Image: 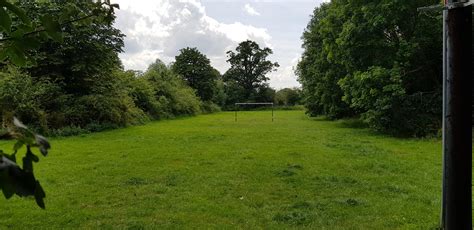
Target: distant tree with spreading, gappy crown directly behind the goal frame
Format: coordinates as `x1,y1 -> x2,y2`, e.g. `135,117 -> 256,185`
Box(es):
223,40 -> 279,101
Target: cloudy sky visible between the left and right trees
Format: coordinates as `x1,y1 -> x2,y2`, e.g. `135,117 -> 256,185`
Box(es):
111,0 -> 324,89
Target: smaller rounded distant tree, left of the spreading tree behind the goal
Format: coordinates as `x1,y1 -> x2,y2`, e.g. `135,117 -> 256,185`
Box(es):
172,47 -> 218,101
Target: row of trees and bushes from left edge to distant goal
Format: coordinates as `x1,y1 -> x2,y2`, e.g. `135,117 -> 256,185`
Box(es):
0,1 -> 299,135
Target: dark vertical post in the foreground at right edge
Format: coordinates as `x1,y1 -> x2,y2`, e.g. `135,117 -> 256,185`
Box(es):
441,0 -> 472,230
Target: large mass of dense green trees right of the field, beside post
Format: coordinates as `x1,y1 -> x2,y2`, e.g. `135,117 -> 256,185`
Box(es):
296,0 -> 442,136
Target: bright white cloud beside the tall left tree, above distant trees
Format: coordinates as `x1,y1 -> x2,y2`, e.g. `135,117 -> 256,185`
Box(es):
115,0 -> 272,73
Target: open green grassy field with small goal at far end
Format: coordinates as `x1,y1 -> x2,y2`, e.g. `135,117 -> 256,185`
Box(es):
0,111 -> 450,229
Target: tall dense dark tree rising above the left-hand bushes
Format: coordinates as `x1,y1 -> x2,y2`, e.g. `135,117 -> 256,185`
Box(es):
20,1 -> 125,97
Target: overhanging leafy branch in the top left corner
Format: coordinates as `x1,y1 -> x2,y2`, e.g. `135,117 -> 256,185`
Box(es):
0,0 -> 119,67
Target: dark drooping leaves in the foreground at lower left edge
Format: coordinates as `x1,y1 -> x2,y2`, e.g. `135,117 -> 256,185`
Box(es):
0,118 -> 51,209
